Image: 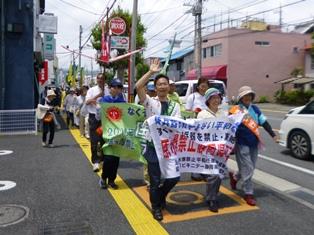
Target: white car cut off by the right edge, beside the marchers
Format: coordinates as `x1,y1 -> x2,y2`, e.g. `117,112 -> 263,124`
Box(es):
279,100 -> 314,159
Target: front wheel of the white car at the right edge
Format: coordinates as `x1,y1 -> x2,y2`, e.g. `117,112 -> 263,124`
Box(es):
288,131 -> 311,160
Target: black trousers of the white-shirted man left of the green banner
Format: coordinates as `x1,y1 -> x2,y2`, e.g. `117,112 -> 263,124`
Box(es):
88,113 -> 103,163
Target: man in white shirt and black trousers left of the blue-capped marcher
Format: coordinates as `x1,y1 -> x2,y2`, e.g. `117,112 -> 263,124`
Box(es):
85,73 -> 105,172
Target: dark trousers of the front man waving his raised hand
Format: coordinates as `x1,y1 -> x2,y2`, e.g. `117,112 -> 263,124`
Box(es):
147,162 -> 180,210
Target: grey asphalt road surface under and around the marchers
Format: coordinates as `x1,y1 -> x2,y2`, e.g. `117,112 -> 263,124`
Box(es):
0,107 -> 314,235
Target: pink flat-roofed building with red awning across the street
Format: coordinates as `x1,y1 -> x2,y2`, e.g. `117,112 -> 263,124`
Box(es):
196,28 -> 311,100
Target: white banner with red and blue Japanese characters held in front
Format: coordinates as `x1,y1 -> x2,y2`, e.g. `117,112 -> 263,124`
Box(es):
148,113 -> 243,178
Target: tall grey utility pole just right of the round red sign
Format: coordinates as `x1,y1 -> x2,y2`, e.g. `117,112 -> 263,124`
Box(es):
128,0 -> 138,102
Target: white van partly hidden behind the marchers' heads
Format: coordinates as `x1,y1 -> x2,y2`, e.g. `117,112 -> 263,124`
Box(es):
175,80 -> 228,104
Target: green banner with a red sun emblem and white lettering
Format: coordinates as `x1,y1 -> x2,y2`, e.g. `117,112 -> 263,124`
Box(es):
101,103 -> 148,163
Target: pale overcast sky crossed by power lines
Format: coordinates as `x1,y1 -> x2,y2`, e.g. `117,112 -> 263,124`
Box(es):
45,0 -> 314,69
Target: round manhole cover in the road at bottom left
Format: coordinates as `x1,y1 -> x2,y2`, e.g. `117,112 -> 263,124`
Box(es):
0,205 -> 29,227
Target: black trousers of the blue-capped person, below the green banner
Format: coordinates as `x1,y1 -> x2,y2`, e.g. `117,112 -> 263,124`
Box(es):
101,155 -> 120,182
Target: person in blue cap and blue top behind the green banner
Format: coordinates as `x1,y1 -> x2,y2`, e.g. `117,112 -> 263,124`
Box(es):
99,79 -> 125,189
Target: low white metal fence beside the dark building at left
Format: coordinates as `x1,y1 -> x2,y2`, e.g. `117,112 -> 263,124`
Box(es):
0,109 -> 37,135
